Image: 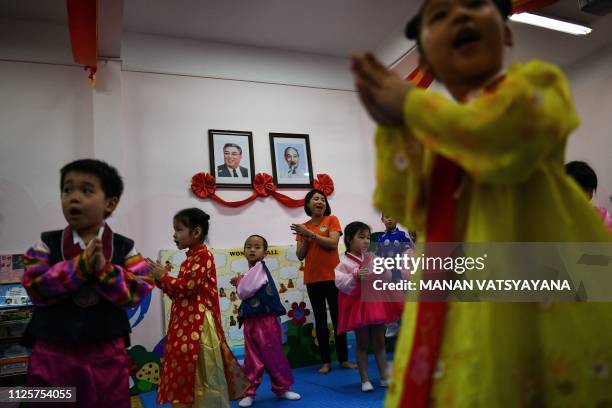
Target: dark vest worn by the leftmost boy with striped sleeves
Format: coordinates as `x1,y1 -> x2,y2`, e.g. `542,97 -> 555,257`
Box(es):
22,227 -> 134,347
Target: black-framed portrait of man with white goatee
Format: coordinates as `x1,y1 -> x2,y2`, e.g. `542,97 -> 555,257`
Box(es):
270,133 -> 313,188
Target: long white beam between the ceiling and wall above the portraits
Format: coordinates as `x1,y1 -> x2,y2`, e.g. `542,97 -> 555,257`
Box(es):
121,32 -> 353,90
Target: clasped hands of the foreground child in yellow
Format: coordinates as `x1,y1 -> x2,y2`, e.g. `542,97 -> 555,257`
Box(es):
352,52 -> 413,127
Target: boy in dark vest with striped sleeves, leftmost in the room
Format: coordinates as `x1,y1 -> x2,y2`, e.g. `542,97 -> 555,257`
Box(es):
21,159 -> 153,408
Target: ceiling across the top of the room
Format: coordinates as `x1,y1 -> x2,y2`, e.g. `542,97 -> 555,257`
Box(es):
0,0 -> 612,65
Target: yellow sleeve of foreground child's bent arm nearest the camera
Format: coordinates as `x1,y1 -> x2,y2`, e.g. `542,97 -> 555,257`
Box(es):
404,61 -> 579,184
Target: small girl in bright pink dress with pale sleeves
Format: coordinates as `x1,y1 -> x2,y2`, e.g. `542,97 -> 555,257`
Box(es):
335,221 -> 402,392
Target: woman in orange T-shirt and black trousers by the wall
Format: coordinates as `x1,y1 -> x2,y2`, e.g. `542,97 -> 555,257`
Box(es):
291,189 -> 357,374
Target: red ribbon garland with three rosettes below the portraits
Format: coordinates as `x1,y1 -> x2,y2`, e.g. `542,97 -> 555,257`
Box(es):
191,172 -> 334,208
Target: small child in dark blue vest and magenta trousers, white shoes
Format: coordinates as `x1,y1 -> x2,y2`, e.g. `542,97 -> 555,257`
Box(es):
238,235 -> 301,407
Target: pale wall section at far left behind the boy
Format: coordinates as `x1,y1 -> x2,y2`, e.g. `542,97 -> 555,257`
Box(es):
0,62 -> 93,253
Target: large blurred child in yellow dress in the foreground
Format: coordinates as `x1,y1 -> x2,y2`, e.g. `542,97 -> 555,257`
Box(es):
353,0 -> 612,408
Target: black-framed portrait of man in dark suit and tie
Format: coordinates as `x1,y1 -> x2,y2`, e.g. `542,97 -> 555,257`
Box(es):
208,129 -> 255,188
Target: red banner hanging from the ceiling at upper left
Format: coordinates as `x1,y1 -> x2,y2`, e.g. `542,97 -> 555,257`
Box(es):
66,0 -> 98,82
